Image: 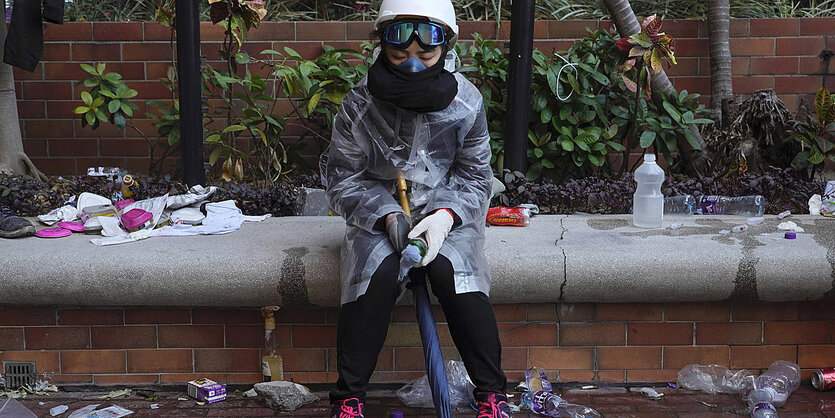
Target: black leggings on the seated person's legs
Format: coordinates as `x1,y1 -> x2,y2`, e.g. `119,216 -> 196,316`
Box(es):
330,254 -> 507,402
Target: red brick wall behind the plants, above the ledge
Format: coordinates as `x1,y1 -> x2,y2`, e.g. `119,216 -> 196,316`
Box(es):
14,18 -> 835,174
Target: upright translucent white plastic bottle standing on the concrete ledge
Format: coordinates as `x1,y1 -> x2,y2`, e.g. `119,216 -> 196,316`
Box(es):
632,154 -> 664,228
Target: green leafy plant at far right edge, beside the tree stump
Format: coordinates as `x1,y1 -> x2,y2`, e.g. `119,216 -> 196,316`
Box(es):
788,87 -> 835,172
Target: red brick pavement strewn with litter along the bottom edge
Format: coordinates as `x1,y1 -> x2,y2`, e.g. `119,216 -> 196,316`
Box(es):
9,385 -> 835,418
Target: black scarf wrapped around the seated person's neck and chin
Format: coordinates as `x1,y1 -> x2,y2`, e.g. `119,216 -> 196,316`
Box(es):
368,48 -> 458,112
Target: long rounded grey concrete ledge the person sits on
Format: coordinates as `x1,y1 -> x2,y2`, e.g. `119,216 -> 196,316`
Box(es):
0,215 -> 835,306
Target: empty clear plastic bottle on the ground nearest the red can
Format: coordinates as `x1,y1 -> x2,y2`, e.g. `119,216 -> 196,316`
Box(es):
748,360 -> 800,418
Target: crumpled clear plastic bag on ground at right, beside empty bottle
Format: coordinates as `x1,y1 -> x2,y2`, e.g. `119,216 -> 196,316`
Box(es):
676,364 -> 754,397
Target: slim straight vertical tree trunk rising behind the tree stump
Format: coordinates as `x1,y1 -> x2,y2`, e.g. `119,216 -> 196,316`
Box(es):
707,0 -> 734,125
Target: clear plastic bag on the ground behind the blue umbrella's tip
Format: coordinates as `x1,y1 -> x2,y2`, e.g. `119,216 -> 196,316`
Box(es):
397,360 -> 475,408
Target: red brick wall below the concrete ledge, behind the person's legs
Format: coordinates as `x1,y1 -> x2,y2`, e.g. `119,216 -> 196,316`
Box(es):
0,302 -> 835,385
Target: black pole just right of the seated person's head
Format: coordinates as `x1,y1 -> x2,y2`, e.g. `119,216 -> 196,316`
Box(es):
504,0 -> 534,173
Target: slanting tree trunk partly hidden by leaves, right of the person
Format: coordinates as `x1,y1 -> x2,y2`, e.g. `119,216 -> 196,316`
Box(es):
603,0 -> 707,177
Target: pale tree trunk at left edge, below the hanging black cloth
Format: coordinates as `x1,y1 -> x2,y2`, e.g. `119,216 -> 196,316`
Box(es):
0,19 -> 46,180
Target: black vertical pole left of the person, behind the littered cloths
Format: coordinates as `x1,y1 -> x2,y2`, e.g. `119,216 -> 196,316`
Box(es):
176,0 -> 206,186
